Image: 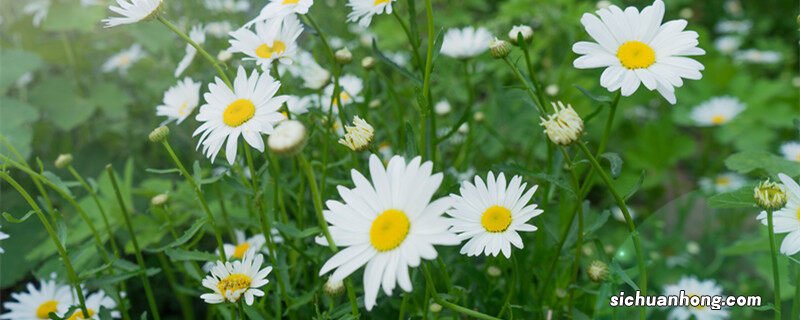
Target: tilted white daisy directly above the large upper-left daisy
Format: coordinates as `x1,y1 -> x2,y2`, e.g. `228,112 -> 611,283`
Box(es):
230,15 -> 303,70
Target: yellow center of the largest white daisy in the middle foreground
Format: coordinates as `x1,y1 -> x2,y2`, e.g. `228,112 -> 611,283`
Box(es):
369,209 -> 411,252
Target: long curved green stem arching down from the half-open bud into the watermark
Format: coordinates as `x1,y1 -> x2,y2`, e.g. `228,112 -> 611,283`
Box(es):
576,141 -> 647,319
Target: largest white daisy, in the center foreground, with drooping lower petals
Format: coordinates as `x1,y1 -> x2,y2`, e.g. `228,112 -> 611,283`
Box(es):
317,154 -> 459,310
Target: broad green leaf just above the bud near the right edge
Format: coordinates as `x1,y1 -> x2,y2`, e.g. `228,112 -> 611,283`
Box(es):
725,151 -> 800,176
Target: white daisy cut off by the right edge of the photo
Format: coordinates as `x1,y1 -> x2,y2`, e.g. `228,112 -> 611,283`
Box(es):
756,173 -> 800,256
